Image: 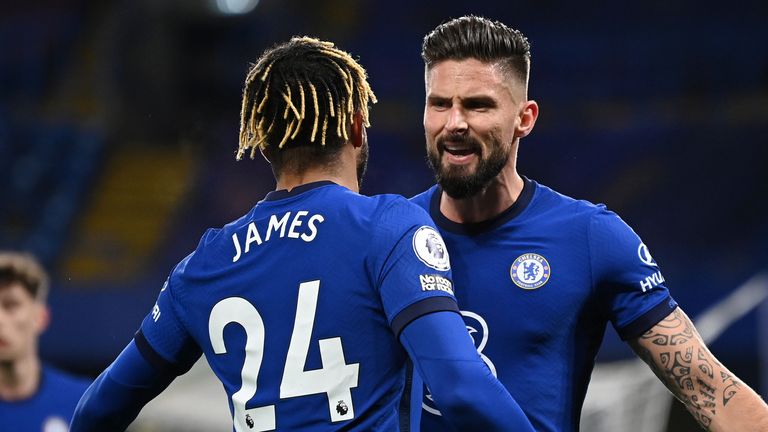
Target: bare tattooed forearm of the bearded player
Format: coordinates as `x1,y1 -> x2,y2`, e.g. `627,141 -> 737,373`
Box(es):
629,308 -> 768,431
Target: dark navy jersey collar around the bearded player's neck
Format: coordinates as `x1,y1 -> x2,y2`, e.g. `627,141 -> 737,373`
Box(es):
429,176 -> 536,235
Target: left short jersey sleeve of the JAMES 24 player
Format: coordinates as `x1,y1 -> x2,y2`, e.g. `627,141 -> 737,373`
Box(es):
134,261 -> 202,375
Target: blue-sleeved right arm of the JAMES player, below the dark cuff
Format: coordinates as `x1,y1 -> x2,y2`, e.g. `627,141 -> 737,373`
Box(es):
400,311 -> 534,432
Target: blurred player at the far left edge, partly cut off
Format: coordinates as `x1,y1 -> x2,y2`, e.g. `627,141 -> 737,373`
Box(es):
0,251 -> 90,432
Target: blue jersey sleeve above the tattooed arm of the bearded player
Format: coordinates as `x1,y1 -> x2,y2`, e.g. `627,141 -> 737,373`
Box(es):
589,207 -> 677,340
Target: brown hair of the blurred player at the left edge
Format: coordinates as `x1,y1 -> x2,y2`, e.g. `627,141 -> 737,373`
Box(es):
0,251 -> 48,303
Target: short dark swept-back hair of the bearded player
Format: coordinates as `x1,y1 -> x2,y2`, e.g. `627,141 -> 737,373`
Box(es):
421,15 -> 531,83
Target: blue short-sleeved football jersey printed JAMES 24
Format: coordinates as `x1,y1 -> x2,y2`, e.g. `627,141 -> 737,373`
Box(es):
135,182 -> 456,432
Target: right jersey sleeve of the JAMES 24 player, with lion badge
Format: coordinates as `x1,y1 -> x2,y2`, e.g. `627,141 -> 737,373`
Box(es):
372,199 -> 458,336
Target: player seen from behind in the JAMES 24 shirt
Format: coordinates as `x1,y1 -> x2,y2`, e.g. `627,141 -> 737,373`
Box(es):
72,37 -> 533,432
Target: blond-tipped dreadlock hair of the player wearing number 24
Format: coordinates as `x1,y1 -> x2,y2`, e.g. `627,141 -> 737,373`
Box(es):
237,37 -> 376,176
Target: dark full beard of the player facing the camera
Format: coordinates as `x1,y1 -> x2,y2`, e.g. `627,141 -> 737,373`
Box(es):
427,135 -> 509,199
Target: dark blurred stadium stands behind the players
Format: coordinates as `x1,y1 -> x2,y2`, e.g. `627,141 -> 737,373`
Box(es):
0,0 -> 768,431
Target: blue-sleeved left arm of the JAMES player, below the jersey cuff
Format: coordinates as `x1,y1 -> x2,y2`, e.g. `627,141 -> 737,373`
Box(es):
69,341 -> 176,432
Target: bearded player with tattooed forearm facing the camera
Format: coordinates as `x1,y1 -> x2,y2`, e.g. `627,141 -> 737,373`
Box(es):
412,16 -> 768,431
